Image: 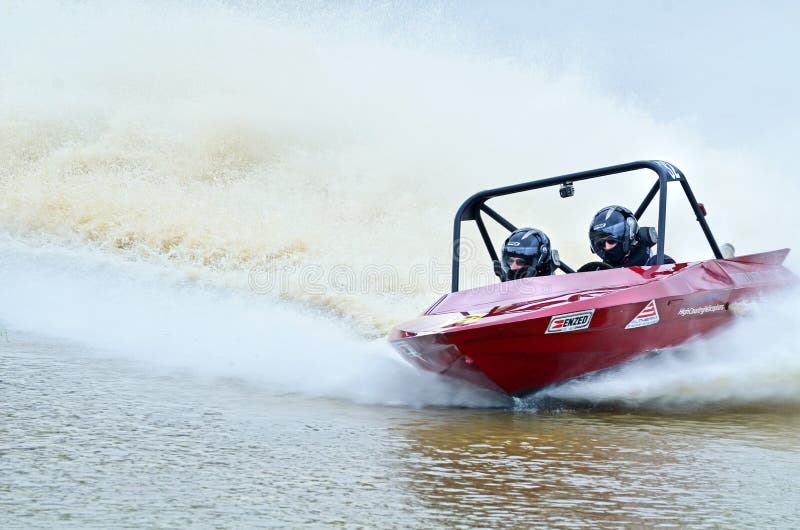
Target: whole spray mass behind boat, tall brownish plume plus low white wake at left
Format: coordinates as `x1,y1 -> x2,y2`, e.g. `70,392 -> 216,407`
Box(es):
0,2 -> 796,403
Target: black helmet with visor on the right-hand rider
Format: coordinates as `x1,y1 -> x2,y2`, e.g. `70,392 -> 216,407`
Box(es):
589,206 -> 639,266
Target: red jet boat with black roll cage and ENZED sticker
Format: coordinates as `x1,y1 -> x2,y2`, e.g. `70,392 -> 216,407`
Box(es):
389,160 -> 797,395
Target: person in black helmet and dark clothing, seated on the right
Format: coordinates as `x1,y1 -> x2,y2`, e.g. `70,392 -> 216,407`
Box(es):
589,205 -> 675,267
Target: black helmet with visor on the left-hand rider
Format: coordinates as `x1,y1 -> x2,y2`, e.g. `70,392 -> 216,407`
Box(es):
500,228 -> 556,281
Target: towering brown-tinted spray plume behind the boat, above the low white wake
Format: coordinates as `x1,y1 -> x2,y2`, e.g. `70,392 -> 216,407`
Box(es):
0,2 -> 796,337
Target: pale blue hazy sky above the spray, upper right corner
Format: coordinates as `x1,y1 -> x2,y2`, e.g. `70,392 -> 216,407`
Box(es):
461,0 -> 800,156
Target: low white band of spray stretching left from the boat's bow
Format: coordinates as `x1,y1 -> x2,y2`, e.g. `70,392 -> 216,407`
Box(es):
0,239 -> 504,406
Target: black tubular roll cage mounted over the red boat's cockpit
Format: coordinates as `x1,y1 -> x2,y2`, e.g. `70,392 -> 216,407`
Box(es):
451,160 -> 722,292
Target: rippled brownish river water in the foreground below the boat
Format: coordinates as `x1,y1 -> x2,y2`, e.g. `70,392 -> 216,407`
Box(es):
0,332 -> 800,528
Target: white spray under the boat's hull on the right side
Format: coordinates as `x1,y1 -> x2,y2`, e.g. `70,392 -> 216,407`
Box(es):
530,290 -> 800,411
